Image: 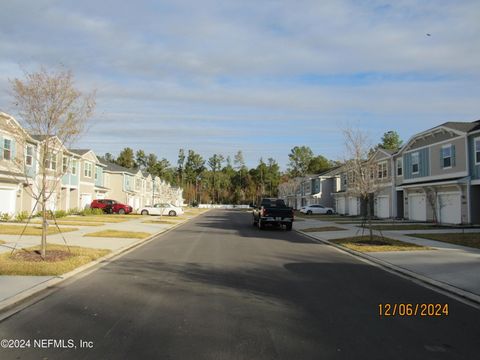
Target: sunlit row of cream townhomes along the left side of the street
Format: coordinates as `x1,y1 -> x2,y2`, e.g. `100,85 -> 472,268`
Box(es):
0,112 -> 183,214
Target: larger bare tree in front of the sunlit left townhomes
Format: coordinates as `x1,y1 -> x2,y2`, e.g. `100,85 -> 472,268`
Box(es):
11,67 -> 95,258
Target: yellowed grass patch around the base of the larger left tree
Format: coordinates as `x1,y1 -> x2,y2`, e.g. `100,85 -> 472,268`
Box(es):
0,244 -> 110,276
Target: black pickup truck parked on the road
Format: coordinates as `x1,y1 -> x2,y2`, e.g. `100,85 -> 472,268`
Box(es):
253,198 -> 294,230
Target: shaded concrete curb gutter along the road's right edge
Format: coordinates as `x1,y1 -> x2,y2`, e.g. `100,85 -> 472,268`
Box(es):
295,230 -> 480,308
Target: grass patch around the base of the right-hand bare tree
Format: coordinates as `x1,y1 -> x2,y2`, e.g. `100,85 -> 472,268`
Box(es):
329,235 -> 430,252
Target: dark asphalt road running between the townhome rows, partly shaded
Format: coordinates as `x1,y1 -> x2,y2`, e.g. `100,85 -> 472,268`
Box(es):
0,210 -> 480,360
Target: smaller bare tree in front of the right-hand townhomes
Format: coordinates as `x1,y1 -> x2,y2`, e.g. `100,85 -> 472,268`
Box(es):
343,128 -> 378,240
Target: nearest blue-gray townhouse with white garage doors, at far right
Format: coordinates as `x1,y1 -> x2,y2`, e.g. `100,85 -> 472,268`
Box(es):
394,121 -> 480,224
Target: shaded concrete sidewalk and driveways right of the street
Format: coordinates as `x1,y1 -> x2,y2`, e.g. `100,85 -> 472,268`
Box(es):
294,219 -> 480,303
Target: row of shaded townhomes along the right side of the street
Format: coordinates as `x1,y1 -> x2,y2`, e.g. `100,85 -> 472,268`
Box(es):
279,120 -> 480,224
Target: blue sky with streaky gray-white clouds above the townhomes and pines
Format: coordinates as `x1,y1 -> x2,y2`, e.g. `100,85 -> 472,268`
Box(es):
0,0 -> 480,169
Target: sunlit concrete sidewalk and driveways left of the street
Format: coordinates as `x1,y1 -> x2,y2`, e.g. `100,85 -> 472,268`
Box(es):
0,212 -> 202,311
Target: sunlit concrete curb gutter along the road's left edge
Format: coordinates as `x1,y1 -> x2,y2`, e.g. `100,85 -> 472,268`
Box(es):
0,211 -> 207,321
